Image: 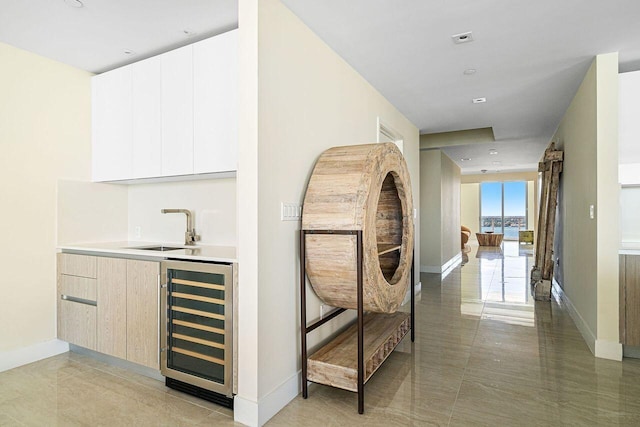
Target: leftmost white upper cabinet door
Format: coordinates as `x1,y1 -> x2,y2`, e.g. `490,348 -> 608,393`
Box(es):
91,66 -> 133,181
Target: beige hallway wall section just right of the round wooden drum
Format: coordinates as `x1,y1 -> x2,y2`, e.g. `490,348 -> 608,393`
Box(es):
420,149 -> 460,272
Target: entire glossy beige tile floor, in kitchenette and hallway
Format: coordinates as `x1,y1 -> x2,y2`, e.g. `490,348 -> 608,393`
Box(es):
0,242 -> 640,426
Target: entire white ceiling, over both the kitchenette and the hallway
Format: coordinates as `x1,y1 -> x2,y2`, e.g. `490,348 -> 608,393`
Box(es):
0,0 -> 640,173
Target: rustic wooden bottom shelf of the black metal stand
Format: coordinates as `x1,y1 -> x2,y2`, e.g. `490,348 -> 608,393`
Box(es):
307,312 -> 411,392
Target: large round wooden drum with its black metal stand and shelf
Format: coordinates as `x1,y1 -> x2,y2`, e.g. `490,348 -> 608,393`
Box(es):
300,143 -> 415,414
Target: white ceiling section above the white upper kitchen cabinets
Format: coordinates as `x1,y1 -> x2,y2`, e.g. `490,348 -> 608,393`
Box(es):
0,0 -> 238,73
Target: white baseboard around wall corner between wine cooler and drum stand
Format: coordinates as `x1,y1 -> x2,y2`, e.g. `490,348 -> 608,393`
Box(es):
233,371 -> 302,427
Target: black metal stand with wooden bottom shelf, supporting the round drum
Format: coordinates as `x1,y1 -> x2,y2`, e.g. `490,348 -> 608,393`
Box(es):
300,230 -> 415,414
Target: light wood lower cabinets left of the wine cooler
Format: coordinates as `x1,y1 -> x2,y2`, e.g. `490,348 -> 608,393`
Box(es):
58,254 -> 160,369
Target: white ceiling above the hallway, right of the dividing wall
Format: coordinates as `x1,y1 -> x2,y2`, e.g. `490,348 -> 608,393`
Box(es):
283,0 -> 640,173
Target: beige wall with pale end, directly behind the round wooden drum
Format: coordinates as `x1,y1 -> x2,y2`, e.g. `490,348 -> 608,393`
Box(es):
235,0 -> 419,422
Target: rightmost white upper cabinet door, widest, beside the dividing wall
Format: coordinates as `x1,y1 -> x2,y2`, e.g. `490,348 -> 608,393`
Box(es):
193,30 -> 238,173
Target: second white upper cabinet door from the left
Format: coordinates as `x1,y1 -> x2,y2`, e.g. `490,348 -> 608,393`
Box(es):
131,56 -> 162,178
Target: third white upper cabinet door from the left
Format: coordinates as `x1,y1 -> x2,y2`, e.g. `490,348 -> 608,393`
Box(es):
160,45 -> 193,176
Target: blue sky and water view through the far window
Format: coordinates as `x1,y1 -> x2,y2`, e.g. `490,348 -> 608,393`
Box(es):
480,181 -> 527,240
